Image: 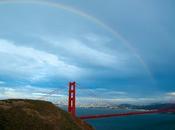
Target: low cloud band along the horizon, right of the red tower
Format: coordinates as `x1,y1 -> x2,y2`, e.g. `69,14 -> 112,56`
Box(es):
77,88 -> 175,106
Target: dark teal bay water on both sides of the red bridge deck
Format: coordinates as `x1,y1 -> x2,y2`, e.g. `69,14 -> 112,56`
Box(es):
77,108 -> 175,130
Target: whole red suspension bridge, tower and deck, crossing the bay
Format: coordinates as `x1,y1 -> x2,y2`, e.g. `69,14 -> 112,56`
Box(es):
40,82 -> 175,119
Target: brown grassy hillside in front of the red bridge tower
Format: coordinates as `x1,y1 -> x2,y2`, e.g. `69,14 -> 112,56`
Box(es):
0,99 -> 93,130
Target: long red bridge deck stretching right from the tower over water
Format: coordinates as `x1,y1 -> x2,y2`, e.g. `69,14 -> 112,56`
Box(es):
79,109 -> 175,119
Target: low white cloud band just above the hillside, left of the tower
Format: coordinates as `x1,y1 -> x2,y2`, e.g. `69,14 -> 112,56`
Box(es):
0,85 -> 67,103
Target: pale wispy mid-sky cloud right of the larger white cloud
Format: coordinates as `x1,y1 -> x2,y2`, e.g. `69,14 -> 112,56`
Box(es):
40,35 -> 127,69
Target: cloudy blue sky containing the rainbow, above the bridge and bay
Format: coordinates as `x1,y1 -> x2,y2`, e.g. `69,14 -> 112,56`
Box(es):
0,0 -> 175,104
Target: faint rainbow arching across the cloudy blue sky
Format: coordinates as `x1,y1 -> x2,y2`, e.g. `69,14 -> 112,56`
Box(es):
0,0 -> 155,84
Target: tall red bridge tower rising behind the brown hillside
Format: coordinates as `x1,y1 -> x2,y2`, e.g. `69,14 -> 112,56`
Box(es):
68,82 -> 76,116
